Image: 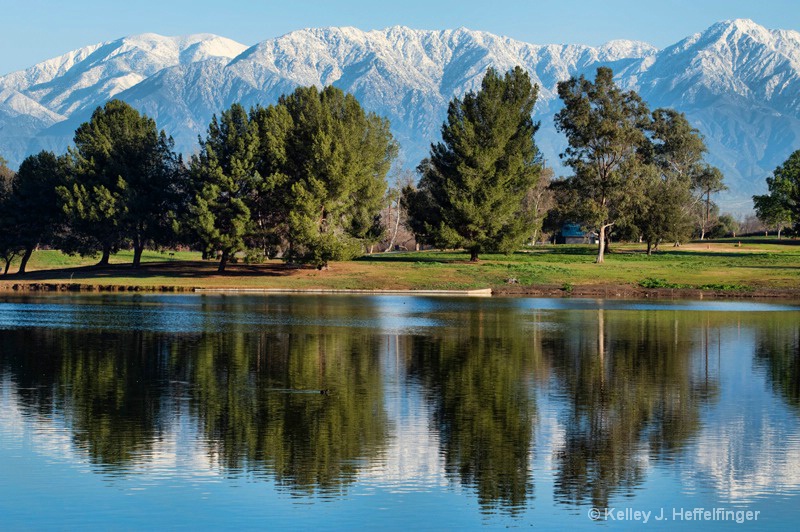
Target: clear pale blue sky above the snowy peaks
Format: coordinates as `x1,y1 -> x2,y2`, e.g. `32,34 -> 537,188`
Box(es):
0,0 -> 800,75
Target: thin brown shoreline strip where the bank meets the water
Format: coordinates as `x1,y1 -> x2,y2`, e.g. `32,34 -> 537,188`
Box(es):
0,281 -> 800,302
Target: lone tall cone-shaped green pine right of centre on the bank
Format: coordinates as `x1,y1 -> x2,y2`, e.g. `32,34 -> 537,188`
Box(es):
407,67 -> 542,261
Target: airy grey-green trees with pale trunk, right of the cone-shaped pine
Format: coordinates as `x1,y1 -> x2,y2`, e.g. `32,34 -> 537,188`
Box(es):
549,68 -> 725,262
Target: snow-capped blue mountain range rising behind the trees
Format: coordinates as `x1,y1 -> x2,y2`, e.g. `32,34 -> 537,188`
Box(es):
0,19 -> 800,212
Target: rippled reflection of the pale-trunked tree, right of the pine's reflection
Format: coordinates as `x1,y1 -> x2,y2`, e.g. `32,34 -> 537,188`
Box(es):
545,310 -> 715,508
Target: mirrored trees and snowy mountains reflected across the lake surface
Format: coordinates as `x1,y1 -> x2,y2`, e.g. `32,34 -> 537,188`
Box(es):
0,297 -> 800,516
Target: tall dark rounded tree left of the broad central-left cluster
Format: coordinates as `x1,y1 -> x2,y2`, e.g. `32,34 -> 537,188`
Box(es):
58,100 -> 183,266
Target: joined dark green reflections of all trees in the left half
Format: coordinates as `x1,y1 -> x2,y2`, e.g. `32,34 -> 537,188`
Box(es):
0,316 -> 388,494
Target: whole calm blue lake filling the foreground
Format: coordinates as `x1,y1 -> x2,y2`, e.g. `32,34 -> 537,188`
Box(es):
0,295 -> 800,530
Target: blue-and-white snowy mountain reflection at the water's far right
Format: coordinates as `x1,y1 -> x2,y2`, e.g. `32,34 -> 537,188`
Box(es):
682,327 -> 800,503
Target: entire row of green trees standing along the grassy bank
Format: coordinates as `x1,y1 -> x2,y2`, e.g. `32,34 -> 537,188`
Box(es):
0,67 -> 800,273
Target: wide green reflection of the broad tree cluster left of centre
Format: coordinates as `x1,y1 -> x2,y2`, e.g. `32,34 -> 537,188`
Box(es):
184,329 -> 388,494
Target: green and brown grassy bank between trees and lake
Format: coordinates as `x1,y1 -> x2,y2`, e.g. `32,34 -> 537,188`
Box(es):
0,239 -> 800,296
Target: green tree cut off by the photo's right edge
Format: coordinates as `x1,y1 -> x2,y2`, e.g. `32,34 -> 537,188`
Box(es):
753,150 -> 800,234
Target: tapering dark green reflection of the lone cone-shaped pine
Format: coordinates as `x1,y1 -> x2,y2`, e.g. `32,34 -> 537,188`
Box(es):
409,307 -> 540,513
